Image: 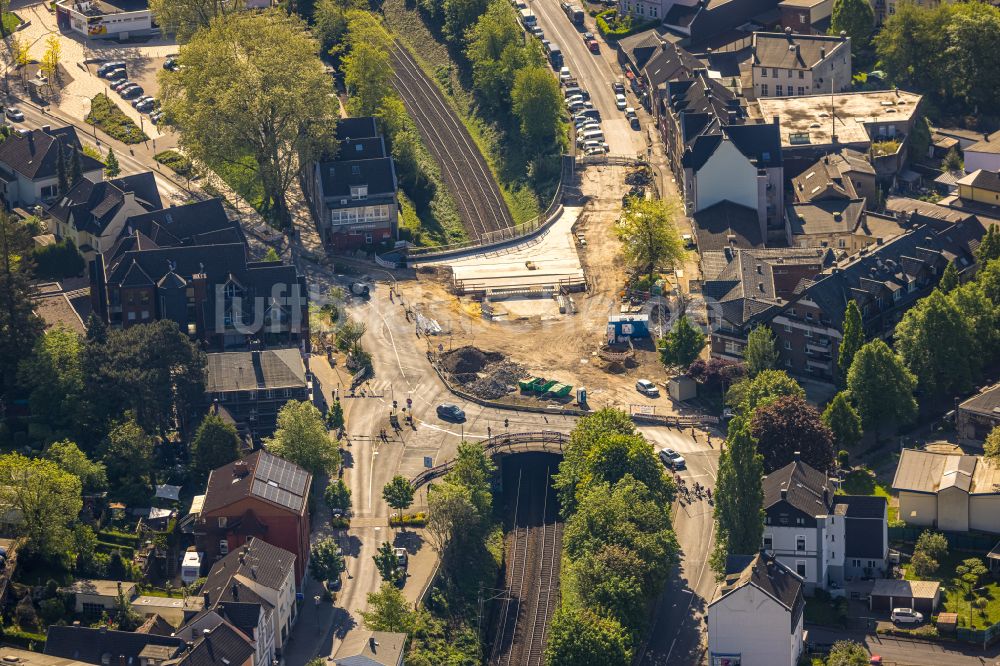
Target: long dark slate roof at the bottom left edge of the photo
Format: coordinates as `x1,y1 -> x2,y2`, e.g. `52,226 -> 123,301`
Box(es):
45,625 -> 185,665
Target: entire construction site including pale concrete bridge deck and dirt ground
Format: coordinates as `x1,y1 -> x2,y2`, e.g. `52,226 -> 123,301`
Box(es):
400,165 -> 703,407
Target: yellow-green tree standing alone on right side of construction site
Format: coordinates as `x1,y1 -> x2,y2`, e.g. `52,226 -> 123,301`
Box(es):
616,197 -> 687,282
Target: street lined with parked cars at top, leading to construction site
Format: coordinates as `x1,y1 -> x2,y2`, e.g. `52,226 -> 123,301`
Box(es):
528,0 -> 646,155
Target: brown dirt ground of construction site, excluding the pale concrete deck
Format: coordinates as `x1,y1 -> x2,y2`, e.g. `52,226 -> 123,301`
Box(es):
399,166 -> 688,413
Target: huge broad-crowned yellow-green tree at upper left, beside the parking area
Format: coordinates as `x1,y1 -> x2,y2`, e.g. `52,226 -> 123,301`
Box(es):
160,9 -> 338,228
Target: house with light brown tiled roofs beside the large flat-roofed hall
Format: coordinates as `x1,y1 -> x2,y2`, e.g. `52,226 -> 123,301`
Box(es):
792,148 -> 879,210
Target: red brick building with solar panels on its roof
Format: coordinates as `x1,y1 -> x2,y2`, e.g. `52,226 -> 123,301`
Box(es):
194,450 -> 312,584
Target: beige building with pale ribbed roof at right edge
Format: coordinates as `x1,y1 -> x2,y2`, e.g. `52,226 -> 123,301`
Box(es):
892,449 -> 1000,534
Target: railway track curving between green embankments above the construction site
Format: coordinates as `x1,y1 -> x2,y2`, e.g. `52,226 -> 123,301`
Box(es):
392,42 -> 514,239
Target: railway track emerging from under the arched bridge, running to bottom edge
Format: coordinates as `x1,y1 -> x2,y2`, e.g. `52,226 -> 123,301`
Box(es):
489,467 -> 562,666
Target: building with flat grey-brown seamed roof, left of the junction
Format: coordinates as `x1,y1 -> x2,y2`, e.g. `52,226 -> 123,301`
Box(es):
205,347 -> 310,439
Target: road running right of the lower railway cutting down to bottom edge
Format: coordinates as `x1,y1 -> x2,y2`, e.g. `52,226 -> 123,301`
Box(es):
636,428 -> 722,666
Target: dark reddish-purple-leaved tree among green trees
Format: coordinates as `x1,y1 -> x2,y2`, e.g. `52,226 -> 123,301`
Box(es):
744,396 -> 834,472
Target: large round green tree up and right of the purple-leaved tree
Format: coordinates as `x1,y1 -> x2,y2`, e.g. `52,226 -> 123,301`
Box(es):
847,339 -> 917,428
